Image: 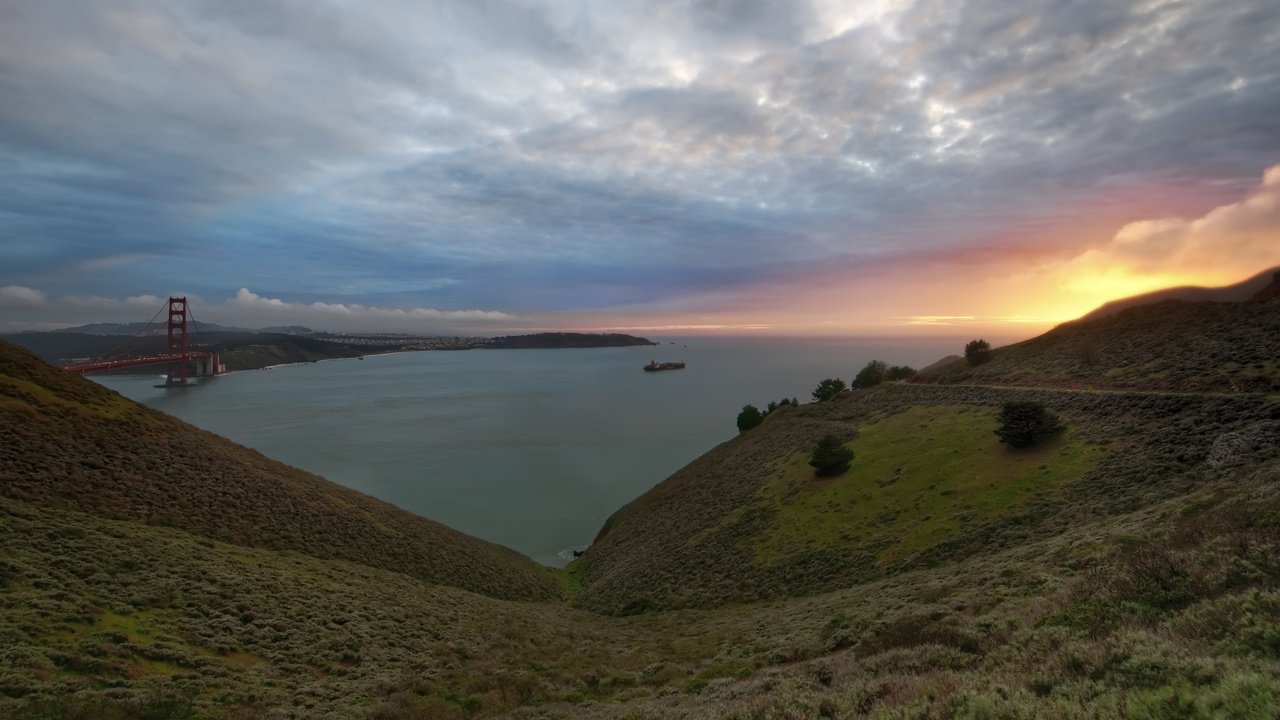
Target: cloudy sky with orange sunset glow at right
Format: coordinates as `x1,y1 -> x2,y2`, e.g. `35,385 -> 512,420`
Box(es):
0,0 -> 1280,337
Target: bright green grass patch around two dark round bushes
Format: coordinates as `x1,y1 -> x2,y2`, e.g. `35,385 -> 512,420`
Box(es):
755,406 -> 1102,564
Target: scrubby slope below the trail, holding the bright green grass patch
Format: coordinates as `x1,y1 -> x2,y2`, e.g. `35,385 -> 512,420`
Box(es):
576,384 -> 1276,614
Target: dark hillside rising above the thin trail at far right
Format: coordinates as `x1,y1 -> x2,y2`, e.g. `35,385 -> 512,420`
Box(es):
922,300 -> 1280,392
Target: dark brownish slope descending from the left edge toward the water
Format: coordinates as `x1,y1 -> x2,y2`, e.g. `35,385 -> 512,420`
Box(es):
0,345 -> 558,598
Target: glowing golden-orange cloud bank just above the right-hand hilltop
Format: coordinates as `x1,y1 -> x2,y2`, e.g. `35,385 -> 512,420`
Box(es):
1060,165 -> 1280,290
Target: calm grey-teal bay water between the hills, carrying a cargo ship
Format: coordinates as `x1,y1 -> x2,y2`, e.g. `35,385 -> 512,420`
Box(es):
95,338 -> 966,566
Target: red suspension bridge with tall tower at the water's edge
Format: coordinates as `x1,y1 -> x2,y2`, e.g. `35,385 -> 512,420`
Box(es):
64,297 -> 227,387
